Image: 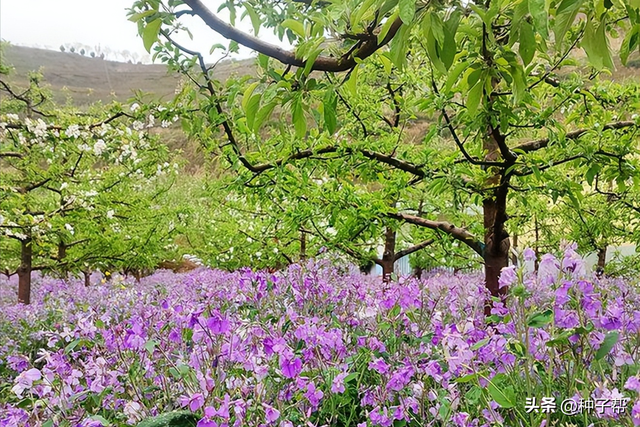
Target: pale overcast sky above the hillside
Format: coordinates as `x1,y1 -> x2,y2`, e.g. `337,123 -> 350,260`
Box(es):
0,0 -> 279,63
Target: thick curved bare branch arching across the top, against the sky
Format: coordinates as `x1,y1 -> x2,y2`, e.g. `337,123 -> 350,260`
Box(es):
181,0 -> 402,72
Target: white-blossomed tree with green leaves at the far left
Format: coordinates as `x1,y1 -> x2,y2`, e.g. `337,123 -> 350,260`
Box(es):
0,74 -> 173,304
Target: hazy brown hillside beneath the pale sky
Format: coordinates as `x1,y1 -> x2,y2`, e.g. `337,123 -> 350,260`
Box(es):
2,46 -> 253,106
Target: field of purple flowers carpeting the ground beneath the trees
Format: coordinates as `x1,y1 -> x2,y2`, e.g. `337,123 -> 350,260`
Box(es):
0,246 -> 640,427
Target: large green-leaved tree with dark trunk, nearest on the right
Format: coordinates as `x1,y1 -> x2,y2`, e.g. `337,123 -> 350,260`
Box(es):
130,0 -> 640,311
